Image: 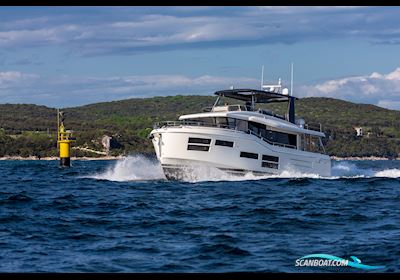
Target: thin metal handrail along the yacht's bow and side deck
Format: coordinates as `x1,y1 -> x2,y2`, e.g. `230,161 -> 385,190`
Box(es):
153,120 -> 297,149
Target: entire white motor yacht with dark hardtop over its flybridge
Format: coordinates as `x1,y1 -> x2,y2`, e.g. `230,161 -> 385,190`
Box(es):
150,79 -> 331,179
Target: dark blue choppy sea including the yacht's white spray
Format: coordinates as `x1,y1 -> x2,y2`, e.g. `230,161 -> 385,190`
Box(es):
0,159 -> 400,272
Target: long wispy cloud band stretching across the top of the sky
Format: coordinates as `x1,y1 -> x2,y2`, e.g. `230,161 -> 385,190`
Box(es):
0,7 -> 400,55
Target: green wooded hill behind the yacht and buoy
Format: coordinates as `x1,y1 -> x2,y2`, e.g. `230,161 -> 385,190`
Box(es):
0,95 -> 400,157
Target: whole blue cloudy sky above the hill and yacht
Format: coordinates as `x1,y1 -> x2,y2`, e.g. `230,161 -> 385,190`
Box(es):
0,6 -> 400,110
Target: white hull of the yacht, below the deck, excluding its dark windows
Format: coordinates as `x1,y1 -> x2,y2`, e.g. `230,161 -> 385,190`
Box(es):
150,126 -> 331,179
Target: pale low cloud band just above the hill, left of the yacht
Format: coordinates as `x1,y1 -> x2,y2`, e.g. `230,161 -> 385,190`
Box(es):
0,71 -> 258,107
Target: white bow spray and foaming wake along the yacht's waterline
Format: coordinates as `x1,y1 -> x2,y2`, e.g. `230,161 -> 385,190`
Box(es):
89,155 -> 400,182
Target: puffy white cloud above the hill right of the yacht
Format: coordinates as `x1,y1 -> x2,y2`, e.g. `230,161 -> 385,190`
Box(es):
297,67 -> 400,110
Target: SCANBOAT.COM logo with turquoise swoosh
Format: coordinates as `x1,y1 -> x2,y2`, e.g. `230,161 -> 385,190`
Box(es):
295,254 -> 385,270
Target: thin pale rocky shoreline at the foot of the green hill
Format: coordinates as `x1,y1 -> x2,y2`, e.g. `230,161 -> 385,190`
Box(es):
0,156 -> 400,160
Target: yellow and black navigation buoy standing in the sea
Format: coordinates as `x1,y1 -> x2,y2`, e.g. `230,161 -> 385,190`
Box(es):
57,110 -> 75,167
